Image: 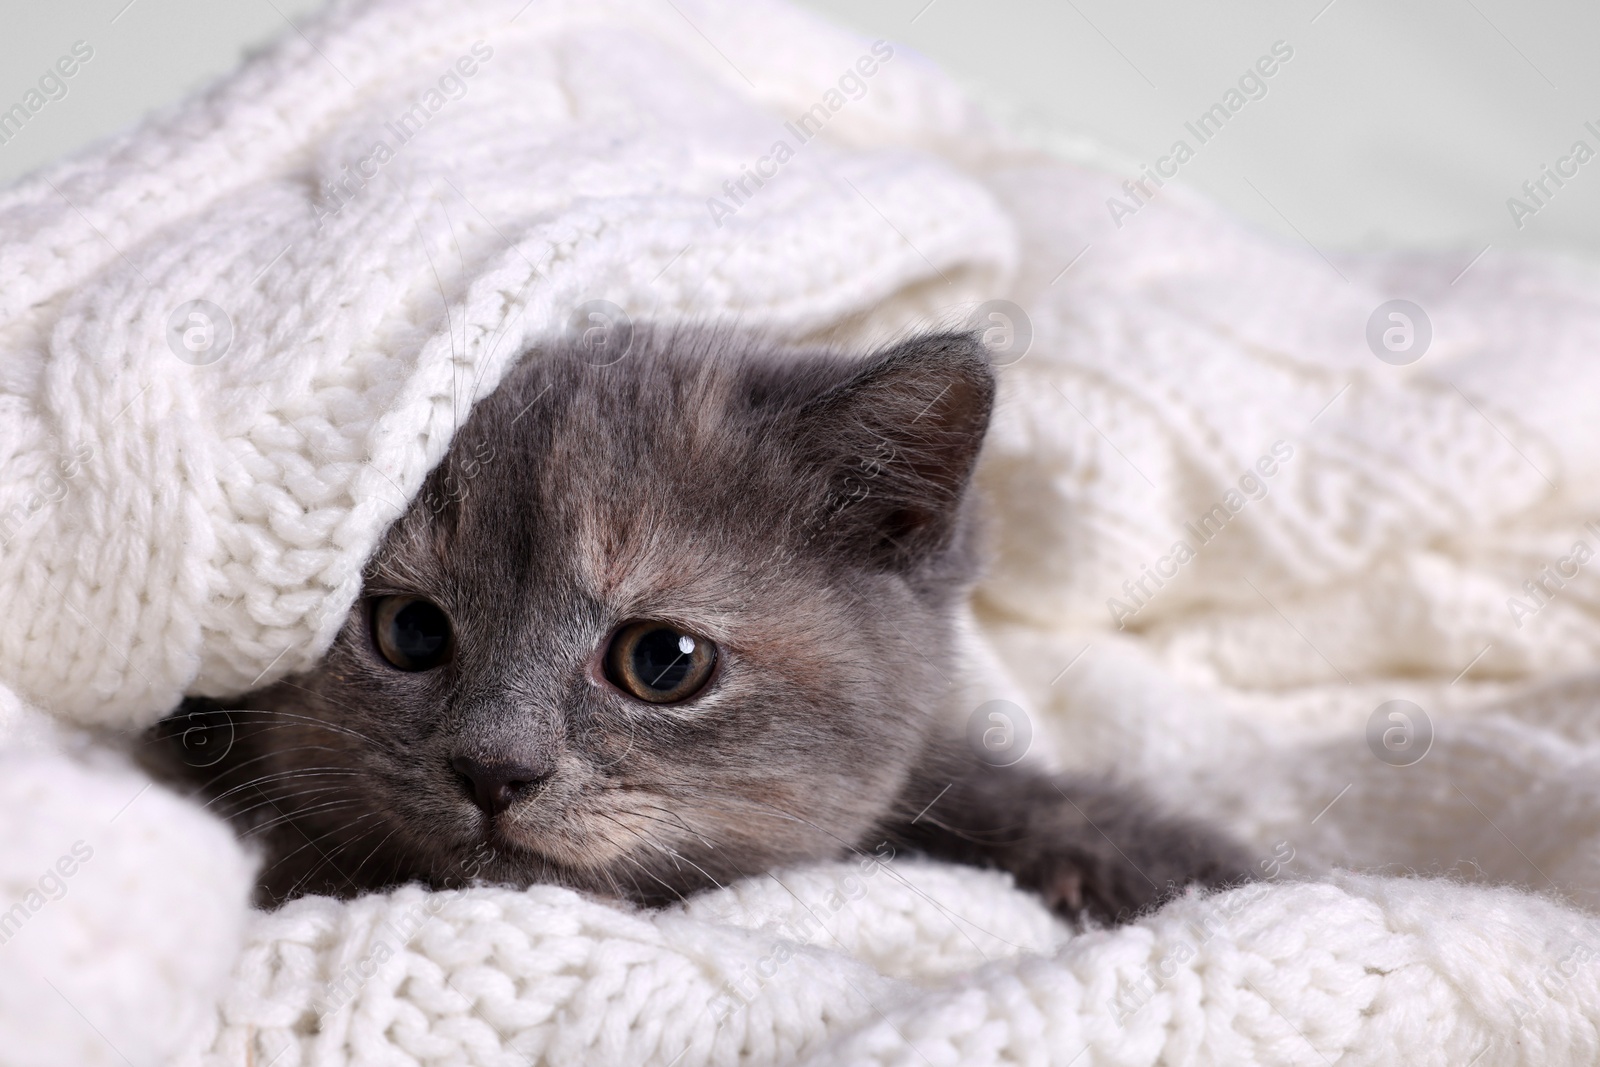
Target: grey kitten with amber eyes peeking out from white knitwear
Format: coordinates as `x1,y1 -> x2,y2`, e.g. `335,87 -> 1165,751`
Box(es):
144,331 -> 1248,921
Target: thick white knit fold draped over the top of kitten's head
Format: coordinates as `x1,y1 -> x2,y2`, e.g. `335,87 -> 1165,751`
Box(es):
0,0 -> 1014,723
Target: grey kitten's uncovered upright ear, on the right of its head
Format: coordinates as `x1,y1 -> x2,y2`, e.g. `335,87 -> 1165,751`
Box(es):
800,333 -> 995,563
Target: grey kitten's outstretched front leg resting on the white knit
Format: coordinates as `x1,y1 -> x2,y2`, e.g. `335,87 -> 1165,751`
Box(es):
883,744 -> 1251,923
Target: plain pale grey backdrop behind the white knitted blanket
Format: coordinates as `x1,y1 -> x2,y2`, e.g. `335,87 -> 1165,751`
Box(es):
0,0 -> 1600,262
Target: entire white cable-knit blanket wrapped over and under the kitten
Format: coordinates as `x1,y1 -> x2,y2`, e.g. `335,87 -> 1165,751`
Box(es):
9,0 -> 1600,1067
